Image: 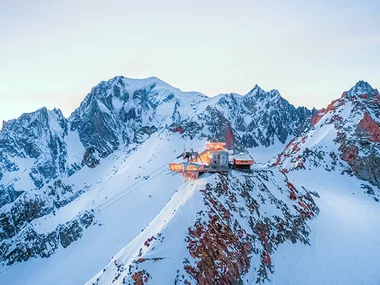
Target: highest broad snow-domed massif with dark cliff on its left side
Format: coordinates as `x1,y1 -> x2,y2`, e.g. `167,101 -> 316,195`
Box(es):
69,77 -> 206,157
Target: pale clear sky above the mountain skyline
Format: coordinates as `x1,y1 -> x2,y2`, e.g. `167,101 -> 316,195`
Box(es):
0,0 -> 380,120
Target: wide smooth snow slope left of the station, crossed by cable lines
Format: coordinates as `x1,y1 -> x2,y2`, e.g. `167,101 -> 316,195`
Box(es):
0,134 -> 196,285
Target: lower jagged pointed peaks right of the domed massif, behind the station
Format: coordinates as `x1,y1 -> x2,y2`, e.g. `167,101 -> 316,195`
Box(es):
183,85 -> 316,149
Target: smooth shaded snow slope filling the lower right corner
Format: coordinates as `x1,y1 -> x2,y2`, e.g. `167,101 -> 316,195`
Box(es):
272,169 -> 380,285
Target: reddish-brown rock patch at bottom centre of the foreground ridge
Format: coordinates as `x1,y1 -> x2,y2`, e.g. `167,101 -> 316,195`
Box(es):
184,185 -> 254,284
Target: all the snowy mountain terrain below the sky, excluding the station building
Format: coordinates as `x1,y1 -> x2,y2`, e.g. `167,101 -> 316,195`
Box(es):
0,76 -> 380,285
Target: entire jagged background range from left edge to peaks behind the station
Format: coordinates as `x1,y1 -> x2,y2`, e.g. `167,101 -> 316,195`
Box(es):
0,77 -> 311,262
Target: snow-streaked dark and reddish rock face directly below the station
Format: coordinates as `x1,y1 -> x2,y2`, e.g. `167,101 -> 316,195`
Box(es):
184,172 -> 319,284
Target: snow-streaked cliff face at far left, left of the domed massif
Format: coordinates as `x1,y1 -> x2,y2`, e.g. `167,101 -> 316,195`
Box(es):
0,108 -> 70,197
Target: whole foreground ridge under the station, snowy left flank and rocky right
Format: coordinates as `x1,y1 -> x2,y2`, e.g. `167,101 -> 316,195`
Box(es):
87,170 -> 319,285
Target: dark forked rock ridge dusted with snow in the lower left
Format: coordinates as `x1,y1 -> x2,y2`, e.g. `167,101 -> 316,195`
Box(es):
0,180 -> 95,265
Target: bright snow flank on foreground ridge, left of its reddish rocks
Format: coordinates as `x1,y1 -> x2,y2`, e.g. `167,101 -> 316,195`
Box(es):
86,178 -> 207,284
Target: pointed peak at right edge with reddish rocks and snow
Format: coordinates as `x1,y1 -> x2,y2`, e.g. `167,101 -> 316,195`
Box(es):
275,81 -> 380,191
